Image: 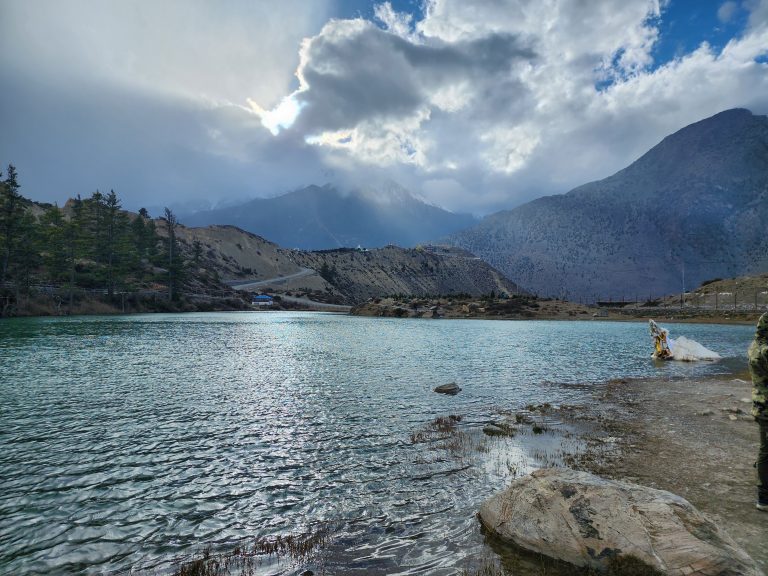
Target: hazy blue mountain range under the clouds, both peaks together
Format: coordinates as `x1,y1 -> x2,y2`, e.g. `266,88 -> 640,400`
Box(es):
184,109 -> 768,301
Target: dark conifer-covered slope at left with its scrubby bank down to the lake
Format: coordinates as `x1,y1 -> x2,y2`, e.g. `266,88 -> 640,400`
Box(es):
0,165 -> 244,315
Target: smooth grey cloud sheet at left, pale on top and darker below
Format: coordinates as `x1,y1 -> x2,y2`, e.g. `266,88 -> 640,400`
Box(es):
0,0 -> 329,208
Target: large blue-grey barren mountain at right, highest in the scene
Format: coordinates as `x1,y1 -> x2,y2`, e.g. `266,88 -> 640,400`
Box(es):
451,109 -> 768,299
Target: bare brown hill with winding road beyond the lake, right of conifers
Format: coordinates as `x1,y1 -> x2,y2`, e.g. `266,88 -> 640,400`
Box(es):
173,226 -> 520,304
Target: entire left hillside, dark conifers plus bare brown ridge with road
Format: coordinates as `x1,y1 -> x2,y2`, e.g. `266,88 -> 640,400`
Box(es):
0,166 -> 519,316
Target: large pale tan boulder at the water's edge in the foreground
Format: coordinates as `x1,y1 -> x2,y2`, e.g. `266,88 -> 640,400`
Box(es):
480,468 -> 762,576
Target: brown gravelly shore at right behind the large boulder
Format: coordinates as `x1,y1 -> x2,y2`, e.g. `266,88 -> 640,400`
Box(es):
561,374 -> 768,572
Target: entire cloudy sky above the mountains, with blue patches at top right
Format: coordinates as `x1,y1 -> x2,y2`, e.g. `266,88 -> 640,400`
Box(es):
0,0 -> 768,215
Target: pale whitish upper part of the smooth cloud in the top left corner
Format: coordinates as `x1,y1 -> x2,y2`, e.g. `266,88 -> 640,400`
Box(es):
0,0 -> 329,106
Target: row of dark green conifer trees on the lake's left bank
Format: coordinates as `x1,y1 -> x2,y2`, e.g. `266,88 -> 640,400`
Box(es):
0,164 -> 184,298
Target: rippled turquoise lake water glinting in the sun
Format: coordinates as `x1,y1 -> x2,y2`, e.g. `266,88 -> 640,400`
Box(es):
0,313 -> 754,574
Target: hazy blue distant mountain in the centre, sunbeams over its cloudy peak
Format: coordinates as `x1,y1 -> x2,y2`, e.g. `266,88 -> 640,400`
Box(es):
183,183 -> 477,250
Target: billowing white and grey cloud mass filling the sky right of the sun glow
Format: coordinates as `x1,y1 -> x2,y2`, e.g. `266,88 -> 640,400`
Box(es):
256,0 -> 768,212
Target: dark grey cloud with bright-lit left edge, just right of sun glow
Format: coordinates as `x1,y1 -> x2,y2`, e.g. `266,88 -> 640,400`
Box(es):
296,21 -> 534,133
